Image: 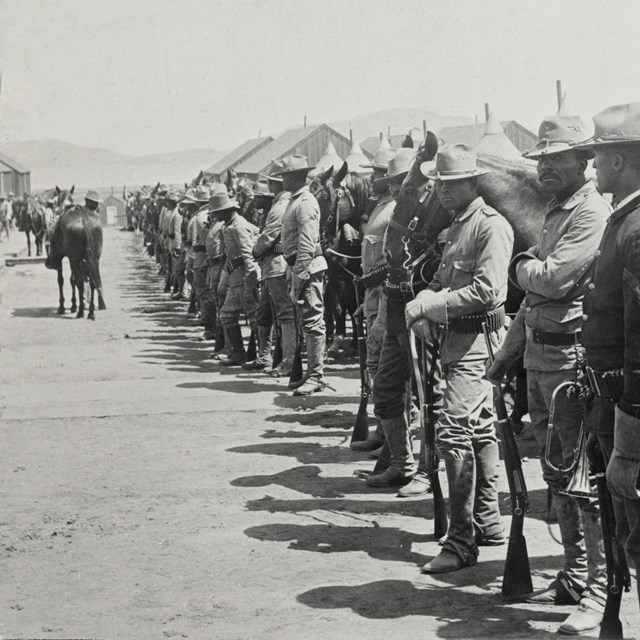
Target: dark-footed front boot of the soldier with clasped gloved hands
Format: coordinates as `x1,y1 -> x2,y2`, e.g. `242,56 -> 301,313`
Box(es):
422,452 -> 478,573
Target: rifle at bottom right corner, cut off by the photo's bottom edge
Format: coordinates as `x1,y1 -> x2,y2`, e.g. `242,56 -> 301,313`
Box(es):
590,441 -> 631,640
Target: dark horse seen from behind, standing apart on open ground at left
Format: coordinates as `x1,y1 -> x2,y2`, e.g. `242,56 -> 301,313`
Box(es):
45,187 -> 107,320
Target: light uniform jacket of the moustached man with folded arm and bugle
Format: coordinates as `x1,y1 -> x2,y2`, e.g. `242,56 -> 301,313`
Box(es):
502,182 -> 611,371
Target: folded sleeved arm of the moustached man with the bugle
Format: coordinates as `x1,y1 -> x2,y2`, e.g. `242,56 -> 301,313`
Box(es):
512,202 -> 610,300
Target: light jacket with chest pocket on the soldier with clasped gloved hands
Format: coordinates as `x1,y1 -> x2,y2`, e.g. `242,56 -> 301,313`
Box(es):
428,197 -> 513,364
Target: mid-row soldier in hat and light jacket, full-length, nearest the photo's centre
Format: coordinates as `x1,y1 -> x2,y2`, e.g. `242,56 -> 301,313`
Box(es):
278,155 -> 327,396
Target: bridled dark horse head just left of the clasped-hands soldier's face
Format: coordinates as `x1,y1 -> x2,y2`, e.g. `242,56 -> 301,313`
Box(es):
384,131 -> 449,286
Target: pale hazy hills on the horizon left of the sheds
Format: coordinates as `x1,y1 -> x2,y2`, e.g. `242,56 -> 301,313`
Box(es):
0,139 -> 226,191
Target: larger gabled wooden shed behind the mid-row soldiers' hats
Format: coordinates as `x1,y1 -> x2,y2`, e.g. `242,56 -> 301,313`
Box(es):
235,124 -> 360,180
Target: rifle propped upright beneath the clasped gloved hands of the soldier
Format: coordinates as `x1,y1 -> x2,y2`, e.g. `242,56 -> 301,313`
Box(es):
409,331 -> 448,538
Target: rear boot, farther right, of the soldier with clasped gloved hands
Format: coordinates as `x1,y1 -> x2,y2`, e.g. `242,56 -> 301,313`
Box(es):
473,438 -> 507,547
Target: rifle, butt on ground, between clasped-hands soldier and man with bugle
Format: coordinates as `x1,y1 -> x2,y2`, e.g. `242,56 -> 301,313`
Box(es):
482,322 -> 533,600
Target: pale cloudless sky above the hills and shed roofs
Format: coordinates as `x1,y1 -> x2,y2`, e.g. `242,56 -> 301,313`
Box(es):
0,0 -> 640,155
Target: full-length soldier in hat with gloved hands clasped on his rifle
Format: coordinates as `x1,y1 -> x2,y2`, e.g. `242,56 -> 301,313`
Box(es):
405,144 -> 513,573
